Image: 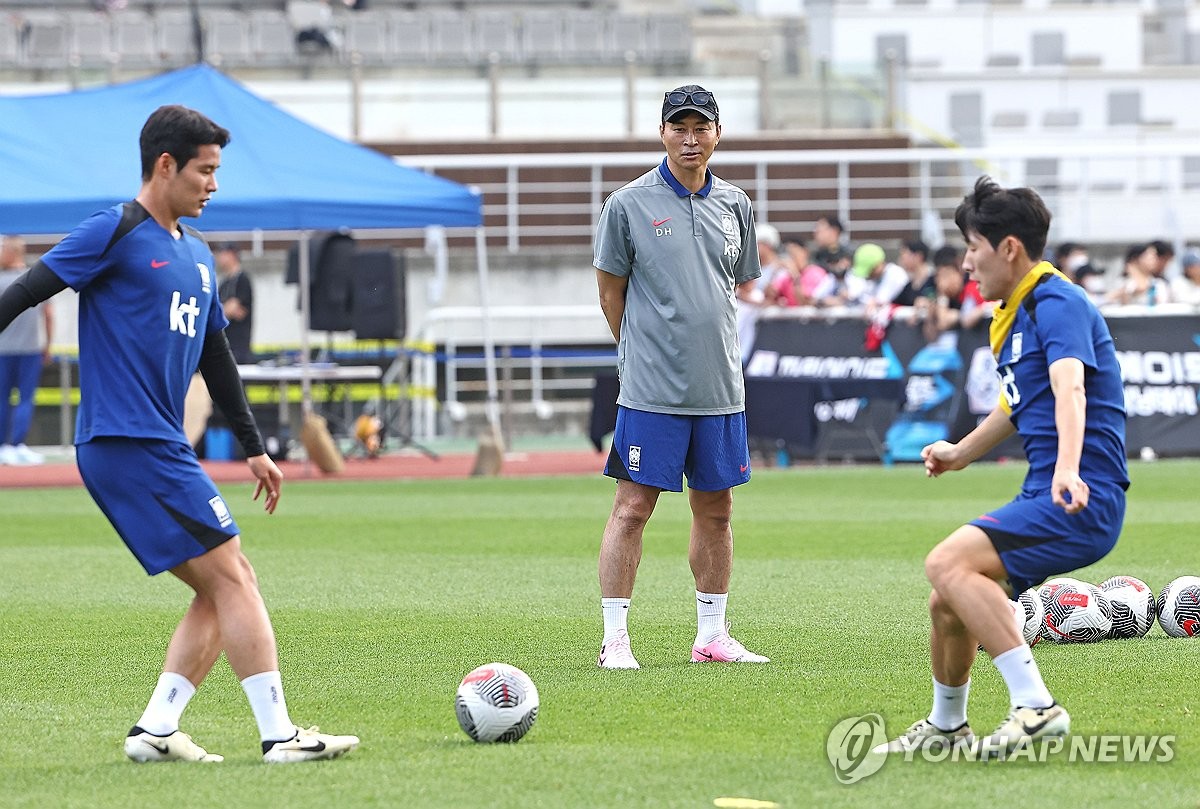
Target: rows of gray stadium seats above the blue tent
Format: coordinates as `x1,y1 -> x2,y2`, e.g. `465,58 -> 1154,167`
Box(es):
0,0 -> 691,70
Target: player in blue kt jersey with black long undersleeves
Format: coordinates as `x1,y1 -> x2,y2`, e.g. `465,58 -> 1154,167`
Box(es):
0,106 -> 359,762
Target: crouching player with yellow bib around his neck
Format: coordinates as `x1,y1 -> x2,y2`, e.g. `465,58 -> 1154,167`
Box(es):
876,176 -> 1129,756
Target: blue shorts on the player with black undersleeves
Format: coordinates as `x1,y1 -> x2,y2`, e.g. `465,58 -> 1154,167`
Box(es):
76,438 -> 240,576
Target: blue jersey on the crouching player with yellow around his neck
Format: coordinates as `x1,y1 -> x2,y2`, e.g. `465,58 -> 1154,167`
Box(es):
997,275 -> 1129,492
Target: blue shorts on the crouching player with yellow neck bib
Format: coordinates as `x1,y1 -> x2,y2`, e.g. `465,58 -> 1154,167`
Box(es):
971,485 -> 1126,595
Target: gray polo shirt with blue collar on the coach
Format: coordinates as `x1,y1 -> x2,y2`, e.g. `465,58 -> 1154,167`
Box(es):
593,160 -> 761,415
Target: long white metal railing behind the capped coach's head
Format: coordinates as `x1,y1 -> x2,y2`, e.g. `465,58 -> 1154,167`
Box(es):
397,144 -> 1200,252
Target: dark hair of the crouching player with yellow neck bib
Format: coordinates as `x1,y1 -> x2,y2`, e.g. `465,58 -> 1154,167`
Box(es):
954,174 -> 1050,260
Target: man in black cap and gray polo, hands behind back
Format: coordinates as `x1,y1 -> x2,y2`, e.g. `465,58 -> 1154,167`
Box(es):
594,84 -> 769,669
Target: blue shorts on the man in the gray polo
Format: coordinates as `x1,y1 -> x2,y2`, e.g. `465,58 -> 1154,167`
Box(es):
604,407 -> 750,492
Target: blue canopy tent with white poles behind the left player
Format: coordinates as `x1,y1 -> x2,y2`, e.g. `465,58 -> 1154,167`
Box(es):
0,64 -> 498,446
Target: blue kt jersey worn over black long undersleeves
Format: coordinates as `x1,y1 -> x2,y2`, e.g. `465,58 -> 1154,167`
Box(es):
42,202 -> 229,444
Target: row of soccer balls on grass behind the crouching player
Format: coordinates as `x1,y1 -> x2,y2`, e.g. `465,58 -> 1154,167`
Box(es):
1010,576 -> 1200,646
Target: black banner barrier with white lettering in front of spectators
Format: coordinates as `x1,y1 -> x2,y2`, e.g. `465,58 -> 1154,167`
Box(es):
589,312 -> 1200,462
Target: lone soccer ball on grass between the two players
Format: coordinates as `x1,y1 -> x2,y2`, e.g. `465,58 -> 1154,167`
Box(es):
454,663 -> 538,742
